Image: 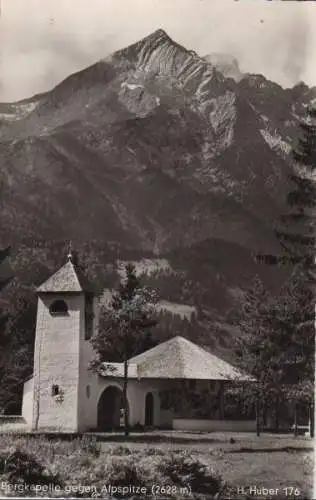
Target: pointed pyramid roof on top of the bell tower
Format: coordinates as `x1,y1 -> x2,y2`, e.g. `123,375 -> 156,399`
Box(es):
37,254 -> 94,293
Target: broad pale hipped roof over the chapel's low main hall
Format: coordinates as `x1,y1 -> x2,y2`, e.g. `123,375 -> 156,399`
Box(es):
100,336 -> 253,381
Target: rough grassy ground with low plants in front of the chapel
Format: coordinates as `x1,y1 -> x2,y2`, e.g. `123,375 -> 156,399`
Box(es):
0,432 -> 314,500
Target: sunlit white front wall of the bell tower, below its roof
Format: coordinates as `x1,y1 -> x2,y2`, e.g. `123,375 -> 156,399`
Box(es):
33,294 -> 83,431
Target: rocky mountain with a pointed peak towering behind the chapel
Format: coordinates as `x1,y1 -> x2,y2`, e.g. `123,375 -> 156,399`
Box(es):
0,30 -> 315,356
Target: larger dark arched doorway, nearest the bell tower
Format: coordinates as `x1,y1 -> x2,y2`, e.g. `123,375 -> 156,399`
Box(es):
98,385 -> 124,431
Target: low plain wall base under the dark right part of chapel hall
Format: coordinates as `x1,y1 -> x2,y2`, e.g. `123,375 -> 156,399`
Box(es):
172,418 -> 256,432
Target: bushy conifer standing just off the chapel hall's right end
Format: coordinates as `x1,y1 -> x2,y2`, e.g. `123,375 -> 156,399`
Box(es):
230,277 -> 292,435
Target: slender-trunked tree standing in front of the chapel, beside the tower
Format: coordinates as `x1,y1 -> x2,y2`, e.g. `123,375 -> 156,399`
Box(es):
91,264 -> 157,436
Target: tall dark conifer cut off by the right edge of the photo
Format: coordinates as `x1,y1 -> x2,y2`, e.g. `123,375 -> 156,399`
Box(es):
259,106 -> 316,436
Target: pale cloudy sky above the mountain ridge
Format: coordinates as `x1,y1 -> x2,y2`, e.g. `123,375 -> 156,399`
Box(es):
0,0 -> 316,102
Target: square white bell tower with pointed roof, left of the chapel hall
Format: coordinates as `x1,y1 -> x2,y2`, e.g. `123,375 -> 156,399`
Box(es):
32,252 -> 97,432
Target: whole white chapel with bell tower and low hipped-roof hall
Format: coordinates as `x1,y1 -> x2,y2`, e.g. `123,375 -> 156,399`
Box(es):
22,253 -> 255,432
